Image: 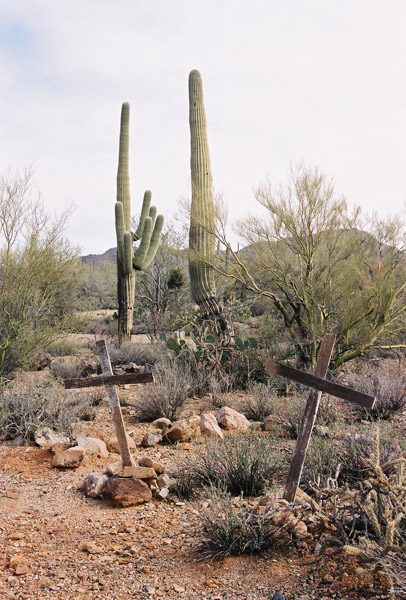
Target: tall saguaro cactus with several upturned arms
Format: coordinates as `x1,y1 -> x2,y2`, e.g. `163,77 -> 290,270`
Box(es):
115,102 -> 164,344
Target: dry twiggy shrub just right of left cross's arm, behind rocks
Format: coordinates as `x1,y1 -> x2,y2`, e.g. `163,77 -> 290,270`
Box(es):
135,363 -> 194,421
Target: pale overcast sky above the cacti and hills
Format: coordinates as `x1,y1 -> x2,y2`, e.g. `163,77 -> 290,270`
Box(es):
0,0 -> 406,254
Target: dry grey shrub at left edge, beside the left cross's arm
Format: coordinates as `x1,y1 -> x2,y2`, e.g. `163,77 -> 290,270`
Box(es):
0,377 -> 96,440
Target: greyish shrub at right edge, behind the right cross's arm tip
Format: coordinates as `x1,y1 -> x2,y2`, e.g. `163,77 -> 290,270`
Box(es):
346,362 -> 406,421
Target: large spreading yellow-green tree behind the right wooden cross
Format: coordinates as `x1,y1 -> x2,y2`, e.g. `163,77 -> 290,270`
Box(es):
215,165 -> 406,368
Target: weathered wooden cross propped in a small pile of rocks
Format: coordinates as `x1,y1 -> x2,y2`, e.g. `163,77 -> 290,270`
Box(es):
64,340 -> 154,468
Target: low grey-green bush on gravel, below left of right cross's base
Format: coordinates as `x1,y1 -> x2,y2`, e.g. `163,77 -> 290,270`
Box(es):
200,488 -> 273,560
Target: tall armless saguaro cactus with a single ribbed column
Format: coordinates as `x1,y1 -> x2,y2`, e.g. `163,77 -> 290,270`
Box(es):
189,71 -> 230,333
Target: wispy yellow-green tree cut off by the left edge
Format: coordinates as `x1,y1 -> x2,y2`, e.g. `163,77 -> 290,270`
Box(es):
0,170 -> 82,376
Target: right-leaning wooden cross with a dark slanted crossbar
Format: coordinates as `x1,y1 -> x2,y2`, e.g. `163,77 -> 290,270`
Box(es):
265,333 -> 376,502
